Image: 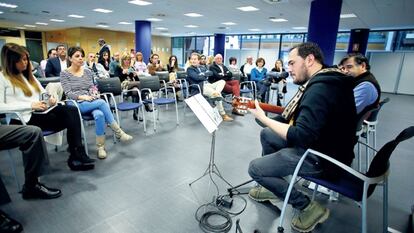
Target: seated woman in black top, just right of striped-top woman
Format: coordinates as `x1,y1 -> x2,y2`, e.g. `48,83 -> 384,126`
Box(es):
115,53 -> 139,121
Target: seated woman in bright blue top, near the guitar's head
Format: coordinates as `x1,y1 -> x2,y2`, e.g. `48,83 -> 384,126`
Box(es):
251,57 -> 270,102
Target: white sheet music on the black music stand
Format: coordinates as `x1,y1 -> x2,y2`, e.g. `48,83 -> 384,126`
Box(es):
185,94 -> 223,133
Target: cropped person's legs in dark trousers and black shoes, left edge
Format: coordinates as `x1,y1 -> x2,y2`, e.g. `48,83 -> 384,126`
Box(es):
0,125 -> 62,233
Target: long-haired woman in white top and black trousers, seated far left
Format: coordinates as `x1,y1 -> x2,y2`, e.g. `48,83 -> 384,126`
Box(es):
0,43 -> 94,171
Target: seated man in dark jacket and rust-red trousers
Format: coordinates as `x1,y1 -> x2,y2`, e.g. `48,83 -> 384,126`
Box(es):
208,54 -> 243,116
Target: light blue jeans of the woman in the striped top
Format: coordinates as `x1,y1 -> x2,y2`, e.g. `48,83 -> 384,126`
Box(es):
78,99 -> 115,136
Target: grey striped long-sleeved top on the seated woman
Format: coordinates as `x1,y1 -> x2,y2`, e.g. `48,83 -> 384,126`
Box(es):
60,69 -> 94,100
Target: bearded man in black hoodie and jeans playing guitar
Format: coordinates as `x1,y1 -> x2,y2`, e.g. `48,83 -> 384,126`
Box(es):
249,43 -> 356,232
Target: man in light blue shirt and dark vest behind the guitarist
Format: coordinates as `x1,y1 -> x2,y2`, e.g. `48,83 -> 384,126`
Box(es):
339,53 -> 381,116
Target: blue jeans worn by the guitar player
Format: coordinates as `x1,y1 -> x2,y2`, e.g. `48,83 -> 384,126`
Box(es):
249,128 -> 322,210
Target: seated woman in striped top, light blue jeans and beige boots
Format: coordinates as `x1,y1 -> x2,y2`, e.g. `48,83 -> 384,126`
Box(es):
60,47 -> 132,159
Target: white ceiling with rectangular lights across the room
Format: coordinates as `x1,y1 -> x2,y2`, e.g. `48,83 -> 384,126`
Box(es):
0,0 -> 414,36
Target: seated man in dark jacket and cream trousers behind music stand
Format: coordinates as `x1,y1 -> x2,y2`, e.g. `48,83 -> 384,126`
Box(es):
187,53 -> 233,121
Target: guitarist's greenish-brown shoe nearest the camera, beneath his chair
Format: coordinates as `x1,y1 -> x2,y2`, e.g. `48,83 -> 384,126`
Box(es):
290,201 -> 329,232
